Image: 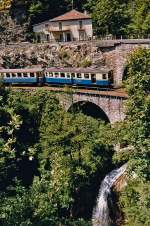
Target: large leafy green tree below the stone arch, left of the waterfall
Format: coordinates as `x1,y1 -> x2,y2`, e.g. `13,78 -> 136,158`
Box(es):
40,94 -> 112,220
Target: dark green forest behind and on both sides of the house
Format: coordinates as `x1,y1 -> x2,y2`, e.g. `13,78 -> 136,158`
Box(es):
0,0 -> 150,37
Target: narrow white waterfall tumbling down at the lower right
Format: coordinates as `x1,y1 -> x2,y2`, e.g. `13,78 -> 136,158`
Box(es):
92,164 -> 127,226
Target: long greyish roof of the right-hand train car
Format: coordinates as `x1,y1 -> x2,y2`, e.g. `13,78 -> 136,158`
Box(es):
45,67 -> 111,73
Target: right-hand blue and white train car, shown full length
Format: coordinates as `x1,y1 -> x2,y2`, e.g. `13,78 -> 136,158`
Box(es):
44,68 -> 112,87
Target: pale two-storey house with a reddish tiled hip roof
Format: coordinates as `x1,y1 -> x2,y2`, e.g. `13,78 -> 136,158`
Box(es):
33,10 -> 93,42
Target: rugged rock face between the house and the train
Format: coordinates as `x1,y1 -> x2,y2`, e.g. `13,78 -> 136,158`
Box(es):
0,44 -> 105,68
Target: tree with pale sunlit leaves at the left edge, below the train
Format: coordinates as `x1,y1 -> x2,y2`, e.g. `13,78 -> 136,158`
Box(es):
0,88 -> 22,190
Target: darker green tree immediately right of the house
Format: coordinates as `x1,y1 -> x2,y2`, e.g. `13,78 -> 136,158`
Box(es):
86,0 -> 130,36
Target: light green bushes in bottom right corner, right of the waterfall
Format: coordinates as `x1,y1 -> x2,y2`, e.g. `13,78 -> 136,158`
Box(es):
121,179 -> 150,226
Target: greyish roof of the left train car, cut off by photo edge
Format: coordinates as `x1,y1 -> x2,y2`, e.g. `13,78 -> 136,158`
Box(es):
0,68 -> 43,73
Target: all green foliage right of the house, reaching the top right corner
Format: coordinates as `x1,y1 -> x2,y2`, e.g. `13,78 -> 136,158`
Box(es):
85,0 -> 150,37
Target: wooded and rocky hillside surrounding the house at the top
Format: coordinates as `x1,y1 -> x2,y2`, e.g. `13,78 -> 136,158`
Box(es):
0,0 -> 150,42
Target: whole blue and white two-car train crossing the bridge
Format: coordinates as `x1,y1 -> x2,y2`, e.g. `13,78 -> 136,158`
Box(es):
0,67 -> 113,87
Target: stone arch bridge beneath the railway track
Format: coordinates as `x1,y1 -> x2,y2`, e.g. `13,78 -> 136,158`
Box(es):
56,90 -> 127,124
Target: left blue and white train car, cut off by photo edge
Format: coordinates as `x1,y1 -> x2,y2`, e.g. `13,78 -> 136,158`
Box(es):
0,68 -> 44,84
